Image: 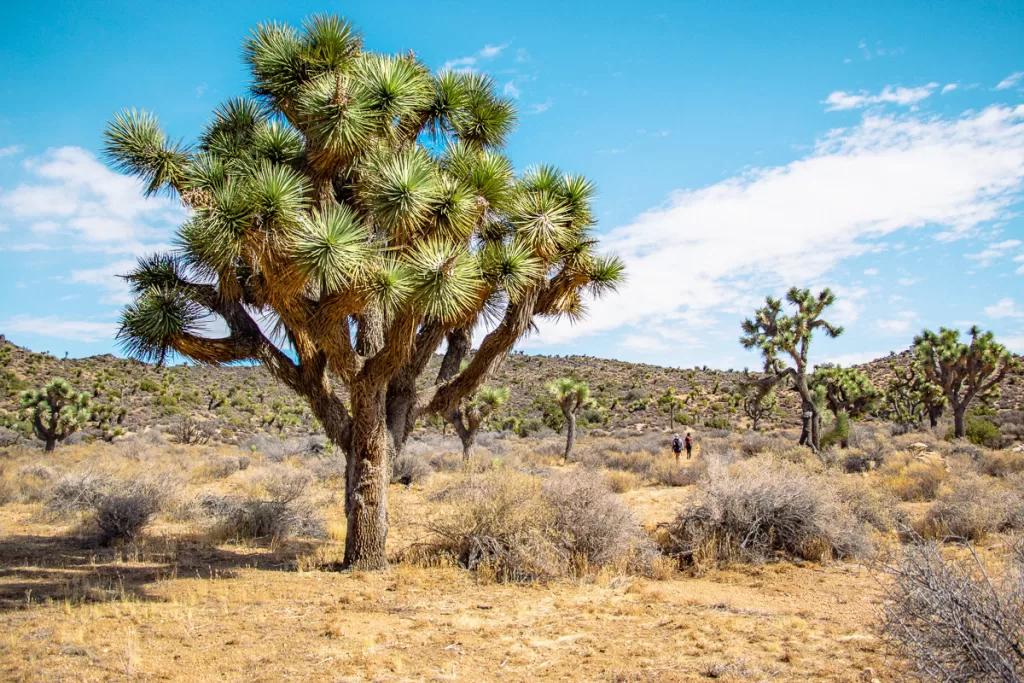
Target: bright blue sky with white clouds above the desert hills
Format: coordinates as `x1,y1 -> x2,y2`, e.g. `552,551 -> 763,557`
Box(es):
0,1 -> 1024,368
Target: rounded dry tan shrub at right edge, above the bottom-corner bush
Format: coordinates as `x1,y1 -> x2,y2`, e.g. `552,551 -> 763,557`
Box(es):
919,474 -> 1016,541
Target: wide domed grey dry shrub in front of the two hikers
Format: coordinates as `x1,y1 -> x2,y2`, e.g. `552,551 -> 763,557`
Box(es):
667,459 -> 869,570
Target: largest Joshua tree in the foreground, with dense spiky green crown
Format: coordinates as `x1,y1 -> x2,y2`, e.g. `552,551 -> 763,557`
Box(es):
105,15 -> 623,568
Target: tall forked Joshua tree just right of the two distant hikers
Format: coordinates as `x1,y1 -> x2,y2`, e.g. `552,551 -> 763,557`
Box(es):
739,287 -> 843,452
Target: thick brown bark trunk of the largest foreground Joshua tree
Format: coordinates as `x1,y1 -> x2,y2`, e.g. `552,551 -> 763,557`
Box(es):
344,388 -> 392,569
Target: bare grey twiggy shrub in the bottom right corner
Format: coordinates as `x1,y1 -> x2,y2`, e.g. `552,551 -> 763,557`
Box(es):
882,542 -> 1024,683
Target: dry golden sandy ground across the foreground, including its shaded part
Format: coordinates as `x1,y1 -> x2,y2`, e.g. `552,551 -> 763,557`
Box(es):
0,487 -> 893,681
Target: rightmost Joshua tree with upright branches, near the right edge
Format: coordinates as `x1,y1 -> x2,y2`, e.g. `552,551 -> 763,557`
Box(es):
913,326 -> 1019,437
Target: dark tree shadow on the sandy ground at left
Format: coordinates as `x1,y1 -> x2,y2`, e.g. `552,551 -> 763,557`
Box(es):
0,535 -> 317,612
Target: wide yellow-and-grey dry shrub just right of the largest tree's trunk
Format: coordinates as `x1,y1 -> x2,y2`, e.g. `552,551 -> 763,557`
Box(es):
421,469 -> 650,581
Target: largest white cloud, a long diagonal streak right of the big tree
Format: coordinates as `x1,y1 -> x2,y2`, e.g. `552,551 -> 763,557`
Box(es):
537,105 -> 1024,345
